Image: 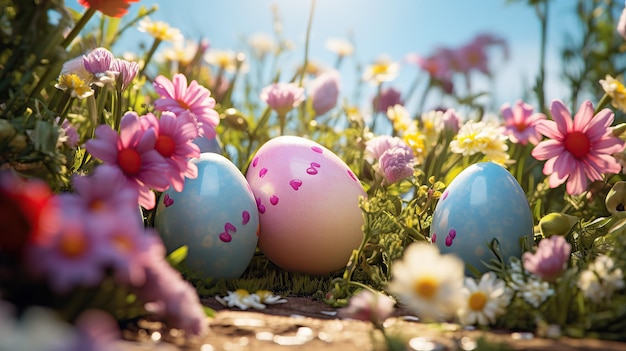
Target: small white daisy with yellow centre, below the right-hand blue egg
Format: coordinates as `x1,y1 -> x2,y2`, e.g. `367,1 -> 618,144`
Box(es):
458,272 -> 511,325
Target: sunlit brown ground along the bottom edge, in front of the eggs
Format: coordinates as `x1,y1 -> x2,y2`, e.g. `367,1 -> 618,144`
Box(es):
113,297 -> 626,351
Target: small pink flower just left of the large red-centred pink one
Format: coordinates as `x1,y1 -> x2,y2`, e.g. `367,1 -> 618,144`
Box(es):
500,100 -> 546,145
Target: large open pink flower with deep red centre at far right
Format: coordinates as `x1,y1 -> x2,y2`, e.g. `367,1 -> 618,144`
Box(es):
532,100 -> 624,195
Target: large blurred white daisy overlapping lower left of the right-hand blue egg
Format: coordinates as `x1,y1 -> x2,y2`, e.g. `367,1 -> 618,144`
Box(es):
389,243 -> 464,320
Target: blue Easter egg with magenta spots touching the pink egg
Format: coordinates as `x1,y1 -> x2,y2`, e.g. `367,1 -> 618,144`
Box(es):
154,152 -> 259,279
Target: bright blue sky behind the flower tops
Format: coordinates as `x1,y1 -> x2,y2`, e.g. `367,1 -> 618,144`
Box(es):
68,0 -> 577,114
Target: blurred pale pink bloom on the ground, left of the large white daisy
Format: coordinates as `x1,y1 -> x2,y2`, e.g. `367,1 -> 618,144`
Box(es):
338,290 -> 395,324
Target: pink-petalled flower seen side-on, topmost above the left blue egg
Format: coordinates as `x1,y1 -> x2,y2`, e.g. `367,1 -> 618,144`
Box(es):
153,73 -> 220,139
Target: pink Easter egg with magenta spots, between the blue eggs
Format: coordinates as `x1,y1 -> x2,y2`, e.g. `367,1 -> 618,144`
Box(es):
246,136 -> 366,275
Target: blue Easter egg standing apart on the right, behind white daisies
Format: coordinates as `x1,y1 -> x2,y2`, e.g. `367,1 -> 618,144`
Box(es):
430,162 -> 533,273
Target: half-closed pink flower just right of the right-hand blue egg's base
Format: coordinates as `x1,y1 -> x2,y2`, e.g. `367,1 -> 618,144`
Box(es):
522,235 -> 572,281
